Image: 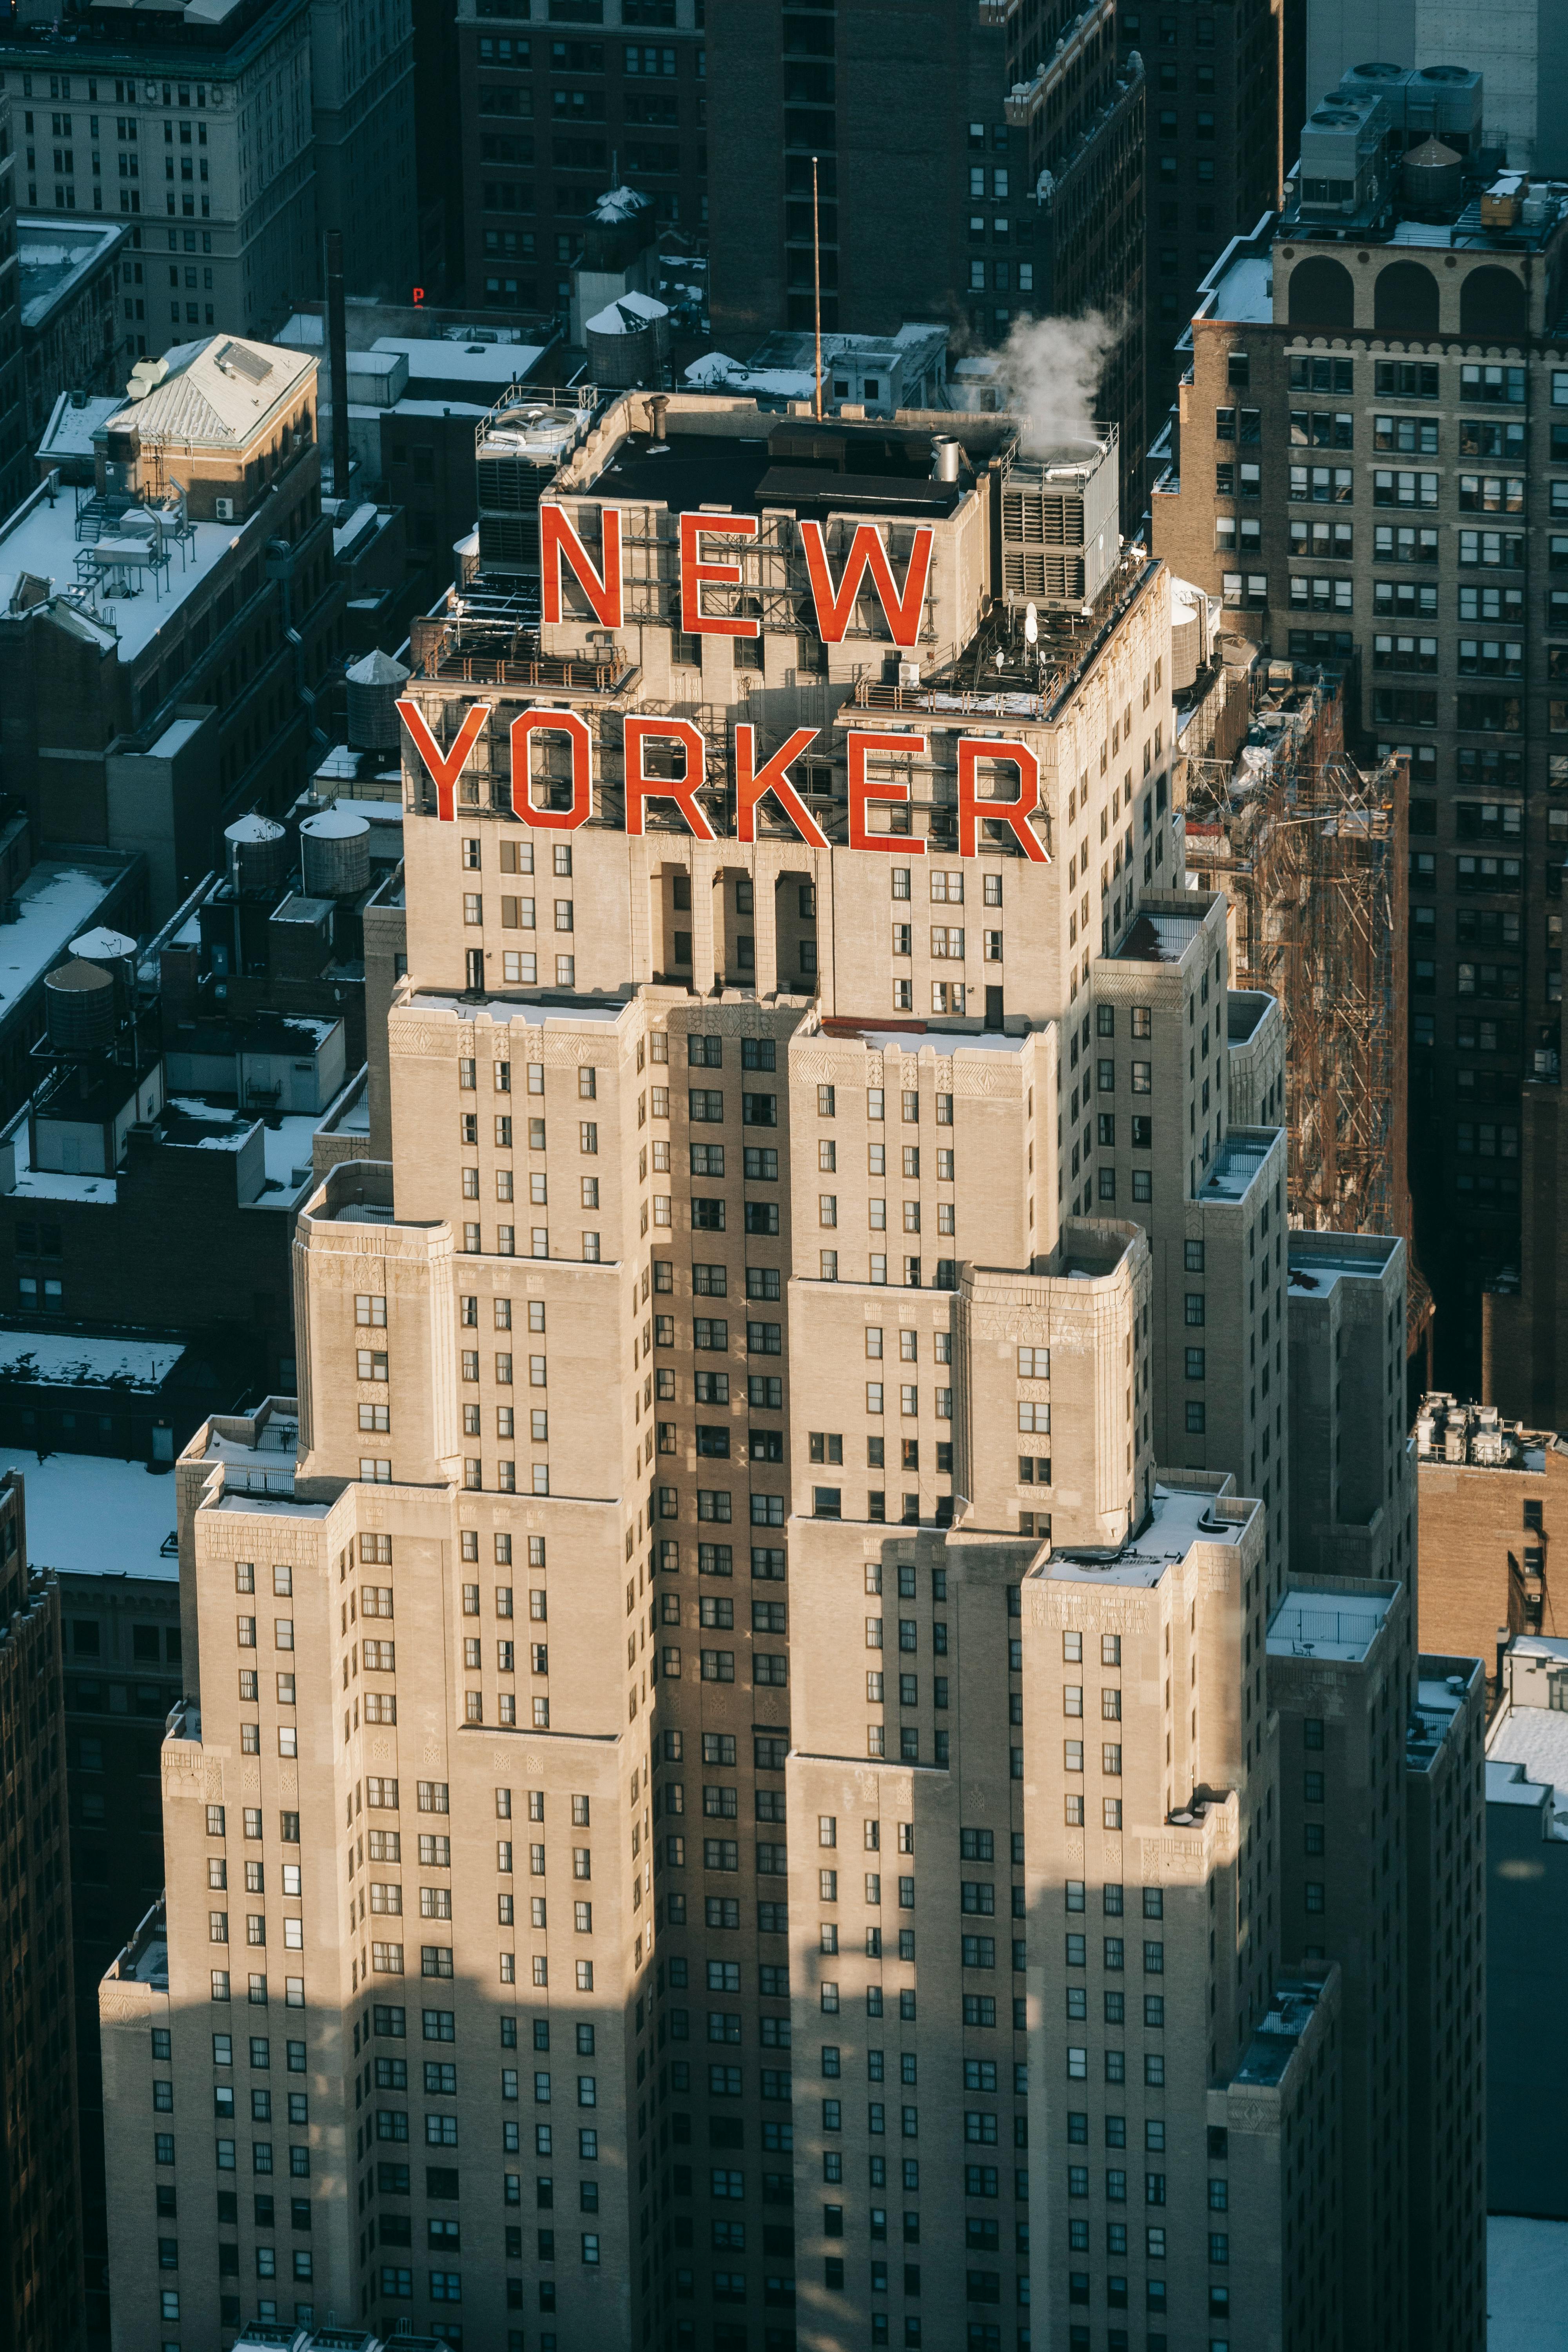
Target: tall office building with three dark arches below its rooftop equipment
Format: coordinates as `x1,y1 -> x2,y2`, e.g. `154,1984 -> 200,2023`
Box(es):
1152,68 -> 1568,1385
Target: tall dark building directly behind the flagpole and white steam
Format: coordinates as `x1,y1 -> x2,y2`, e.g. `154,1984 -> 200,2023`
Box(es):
708,0 -> 1145,513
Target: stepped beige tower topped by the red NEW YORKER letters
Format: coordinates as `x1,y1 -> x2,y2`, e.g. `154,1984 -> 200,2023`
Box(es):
103,395 -> 1465,2352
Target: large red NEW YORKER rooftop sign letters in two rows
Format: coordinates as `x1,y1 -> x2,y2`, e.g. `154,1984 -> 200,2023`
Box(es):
397,506 -> 1049,866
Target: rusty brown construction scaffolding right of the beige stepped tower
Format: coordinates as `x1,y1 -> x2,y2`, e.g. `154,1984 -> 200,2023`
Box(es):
1185,663 -> 1432,1341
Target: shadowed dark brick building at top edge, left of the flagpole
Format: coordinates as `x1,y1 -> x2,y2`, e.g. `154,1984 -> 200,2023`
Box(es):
456,0 -> 708,313
